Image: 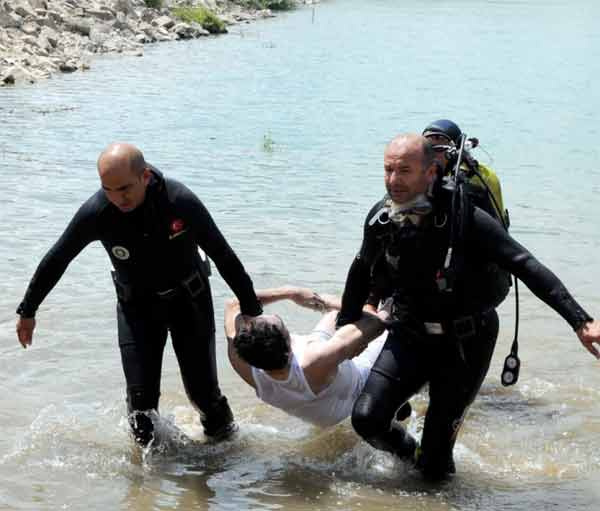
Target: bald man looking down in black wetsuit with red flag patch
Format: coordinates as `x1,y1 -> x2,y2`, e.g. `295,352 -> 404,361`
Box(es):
17,144 -> 262,445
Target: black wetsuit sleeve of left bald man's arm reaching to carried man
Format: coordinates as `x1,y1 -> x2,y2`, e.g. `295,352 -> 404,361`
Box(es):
186,192 -> 262,316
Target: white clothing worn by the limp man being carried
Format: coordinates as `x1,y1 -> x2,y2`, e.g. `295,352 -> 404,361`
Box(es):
252,331 -> 387,427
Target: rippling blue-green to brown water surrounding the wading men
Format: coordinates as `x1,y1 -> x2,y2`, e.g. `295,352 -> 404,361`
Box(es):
0,0 -> 600,511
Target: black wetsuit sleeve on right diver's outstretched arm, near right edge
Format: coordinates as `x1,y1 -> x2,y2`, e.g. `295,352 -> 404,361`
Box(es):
473,208 -> 592,330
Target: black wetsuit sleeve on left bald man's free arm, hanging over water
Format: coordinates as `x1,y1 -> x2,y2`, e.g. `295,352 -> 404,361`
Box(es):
17,200 -> 98,318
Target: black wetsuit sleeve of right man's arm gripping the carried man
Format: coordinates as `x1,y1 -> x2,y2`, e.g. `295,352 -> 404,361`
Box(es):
336,203 -> 381,328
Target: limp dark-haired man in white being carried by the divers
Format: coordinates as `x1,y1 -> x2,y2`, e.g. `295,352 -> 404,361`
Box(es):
225,286 -> 410,427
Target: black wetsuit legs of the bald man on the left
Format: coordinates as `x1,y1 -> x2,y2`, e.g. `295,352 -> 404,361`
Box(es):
117,289 -> 233,445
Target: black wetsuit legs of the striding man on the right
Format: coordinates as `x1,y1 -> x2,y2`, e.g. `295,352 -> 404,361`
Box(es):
352,311 -> 498,478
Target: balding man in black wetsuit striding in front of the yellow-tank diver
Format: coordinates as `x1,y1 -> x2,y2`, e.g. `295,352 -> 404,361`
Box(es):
338,135 -> 600,479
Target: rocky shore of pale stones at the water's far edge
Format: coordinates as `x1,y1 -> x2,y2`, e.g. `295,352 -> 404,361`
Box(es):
0,0 -> 312,86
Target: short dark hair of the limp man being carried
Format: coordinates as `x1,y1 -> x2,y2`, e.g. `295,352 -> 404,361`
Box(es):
233,321 -> 290,371
